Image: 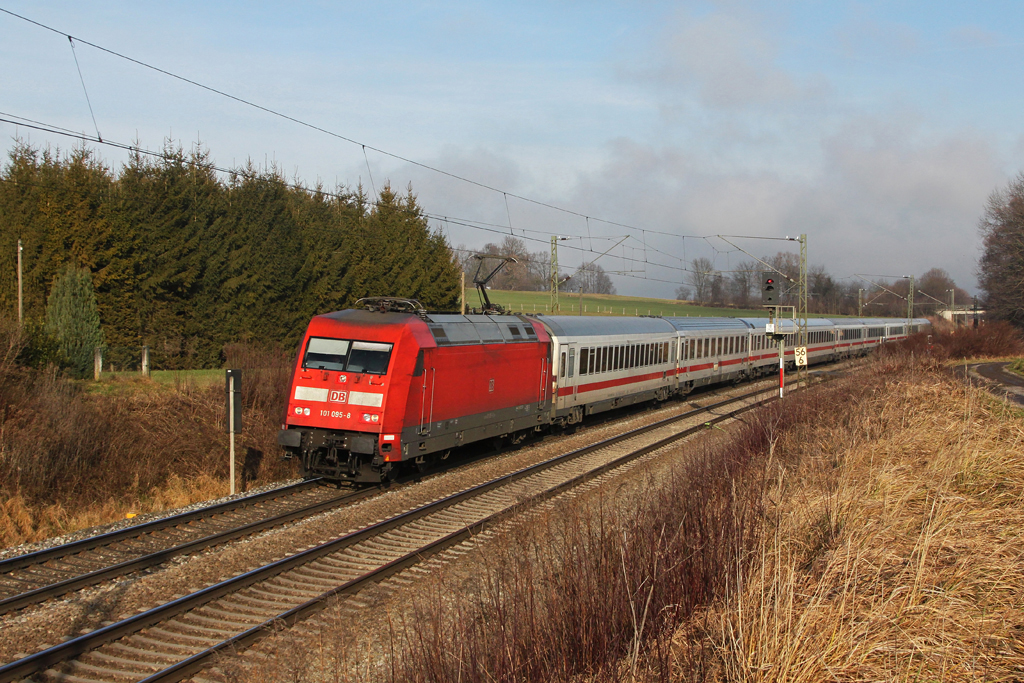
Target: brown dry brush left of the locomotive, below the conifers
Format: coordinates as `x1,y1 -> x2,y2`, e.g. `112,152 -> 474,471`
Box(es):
0,321 -> 291,546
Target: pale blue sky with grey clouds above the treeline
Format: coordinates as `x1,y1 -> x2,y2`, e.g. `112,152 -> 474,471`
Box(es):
0,0 -> 1024,296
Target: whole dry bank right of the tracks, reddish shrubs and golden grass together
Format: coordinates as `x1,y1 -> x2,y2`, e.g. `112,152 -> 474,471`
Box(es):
390,330 -> 1024,682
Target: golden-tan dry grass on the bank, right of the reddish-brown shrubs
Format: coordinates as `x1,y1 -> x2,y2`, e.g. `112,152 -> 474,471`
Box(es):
675,364 -> 1024,681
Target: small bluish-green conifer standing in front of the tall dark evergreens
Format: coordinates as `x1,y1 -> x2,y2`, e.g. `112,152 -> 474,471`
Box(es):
46,265 -> 103,377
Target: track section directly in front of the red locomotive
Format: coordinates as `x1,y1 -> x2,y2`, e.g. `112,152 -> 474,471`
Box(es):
0,480 -> 372,615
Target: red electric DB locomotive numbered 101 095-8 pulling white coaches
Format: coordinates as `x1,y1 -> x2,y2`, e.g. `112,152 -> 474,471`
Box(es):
278,299 -> 551,483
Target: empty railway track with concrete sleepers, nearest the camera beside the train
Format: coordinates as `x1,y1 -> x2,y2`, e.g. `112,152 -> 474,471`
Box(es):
0,388 -> 774,683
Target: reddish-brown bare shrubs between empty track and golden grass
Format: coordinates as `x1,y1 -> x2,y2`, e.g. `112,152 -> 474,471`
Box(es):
394,385 -> 864,683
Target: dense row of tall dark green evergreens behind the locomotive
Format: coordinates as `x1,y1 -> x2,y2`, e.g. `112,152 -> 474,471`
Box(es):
0,140 -> 460,369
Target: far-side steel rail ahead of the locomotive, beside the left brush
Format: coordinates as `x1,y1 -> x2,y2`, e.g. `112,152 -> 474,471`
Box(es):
0,478 -> 319,573
